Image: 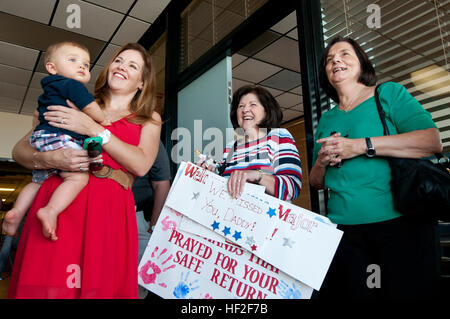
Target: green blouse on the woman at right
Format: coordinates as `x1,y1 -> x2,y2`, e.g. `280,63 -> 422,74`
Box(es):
313,82 -> 436,225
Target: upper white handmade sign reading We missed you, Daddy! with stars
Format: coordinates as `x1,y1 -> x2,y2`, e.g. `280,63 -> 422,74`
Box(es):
166,163 -> 342,290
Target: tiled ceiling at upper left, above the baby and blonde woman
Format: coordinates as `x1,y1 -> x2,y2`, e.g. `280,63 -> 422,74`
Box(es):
0,0 -> 170,114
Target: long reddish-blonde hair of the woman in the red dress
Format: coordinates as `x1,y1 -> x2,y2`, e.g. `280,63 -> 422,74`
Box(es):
94,43 -> 161,124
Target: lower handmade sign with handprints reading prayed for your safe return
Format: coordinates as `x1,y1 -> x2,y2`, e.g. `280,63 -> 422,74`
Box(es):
138,206 -> 313,299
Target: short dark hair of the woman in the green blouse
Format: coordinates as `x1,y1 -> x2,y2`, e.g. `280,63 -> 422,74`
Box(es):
319,35 -> 377,103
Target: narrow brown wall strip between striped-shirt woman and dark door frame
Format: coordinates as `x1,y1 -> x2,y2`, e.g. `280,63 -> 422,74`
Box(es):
281,118 -> 311,210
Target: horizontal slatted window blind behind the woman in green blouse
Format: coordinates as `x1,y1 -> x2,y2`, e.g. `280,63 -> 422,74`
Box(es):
321,0 -> 450,153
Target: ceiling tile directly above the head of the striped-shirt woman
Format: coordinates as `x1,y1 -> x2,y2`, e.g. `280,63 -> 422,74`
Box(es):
233,59 -> 281,83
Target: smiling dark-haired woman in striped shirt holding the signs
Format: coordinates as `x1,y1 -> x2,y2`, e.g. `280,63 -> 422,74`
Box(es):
203,85 -> 302,201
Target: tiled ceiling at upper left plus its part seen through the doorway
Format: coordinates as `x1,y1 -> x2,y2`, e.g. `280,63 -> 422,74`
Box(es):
0,0 -> 303,121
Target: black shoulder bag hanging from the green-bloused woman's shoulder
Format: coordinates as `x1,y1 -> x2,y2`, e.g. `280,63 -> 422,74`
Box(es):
375,85 -> 450,221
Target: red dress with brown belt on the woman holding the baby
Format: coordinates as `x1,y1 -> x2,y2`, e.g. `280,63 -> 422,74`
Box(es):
8,119 -> 141,299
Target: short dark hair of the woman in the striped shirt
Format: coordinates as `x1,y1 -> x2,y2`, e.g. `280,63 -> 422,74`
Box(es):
230,85 -> 283,129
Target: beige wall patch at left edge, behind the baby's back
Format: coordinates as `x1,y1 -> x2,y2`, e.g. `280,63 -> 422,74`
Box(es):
0,112 -> 33,159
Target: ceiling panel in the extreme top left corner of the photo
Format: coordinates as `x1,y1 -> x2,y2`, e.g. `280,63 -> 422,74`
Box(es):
0,0 -> 56,24
